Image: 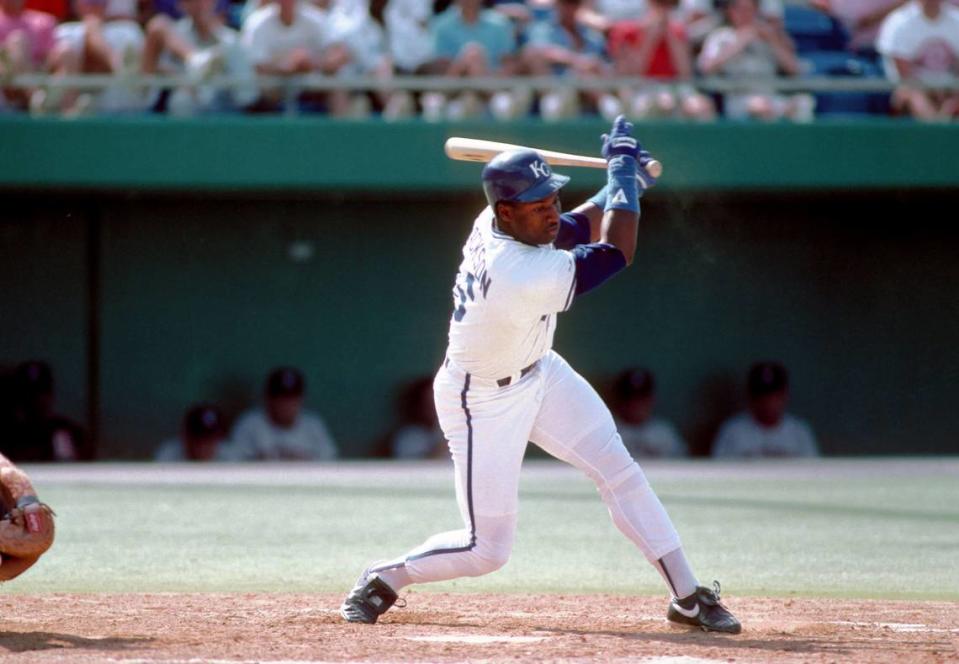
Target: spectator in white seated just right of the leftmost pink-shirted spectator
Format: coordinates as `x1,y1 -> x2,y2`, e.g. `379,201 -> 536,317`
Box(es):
36,0 -> 146,114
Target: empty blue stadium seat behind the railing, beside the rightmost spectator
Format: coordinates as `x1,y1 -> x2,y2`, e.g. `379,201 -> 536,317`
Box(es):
802,51 -> 889,116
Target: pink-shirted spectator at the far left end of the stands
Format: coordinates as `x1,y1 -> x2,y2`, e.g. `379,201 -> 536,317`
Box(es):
0,0 -> 56,110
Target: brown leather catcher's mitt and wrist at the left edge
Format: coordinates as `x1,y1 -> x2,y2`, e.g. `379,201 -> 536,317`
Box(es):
0,454 -> 54,581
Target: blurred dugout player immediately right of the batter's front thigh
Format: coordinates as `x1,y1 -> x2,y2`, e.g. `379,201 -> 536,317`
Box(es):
614,368 -> 689,459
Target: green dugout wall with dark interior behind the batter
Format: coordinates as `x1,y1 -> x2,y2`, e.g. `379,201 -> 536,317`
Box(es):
0,118 -> 959,458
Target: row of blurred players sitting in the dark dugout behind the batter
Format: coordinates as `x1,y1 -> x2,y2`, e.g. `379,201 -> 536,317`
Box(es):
0,361 -> 820,462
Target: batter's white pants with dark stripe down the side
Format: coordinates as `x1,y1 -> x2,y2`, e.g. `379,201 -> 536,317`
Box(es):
371,351 -> 681,583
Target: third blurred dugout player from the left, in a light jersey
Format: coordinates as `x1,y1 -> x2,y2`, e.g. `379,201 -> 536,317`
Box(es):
227,367 -> 337,461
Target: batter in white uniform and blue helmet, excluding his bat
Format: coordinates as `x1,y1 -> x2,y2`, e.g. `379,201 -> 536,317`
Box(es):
340,116 -> 740,634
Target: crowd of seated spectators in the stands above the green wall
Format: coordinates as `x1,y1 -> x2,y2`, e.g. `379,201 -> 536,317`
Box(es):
0,0 -> 959,121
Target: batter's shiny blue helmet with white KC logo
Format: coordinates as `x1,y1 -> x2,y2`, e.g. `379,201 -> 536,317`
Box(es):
483,150 -> 569,208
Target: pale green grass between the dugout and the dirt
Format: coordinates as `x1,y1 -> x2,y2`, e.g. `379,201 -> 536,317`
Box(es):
3,460 -> 959,600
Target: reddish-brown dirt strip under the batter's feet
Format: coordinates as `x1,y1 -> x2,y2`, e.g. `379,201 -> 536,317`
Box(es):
0,593 -> 959,664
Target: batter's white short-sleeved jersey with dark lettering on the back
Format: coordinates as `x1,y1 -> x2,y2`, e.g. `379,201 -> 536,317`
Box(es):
447,207 -> 576,380
